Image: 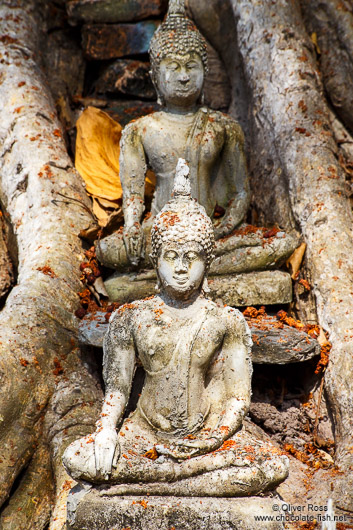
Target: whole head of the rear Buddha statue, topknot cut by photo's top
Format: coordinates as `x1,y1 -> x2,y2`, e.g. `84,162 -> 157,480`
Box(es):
149,0 -> 207,107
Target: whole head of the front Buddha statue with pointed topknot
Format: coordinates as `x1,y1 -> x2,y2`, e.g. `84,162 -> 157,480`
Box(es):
151,158 -> 214,300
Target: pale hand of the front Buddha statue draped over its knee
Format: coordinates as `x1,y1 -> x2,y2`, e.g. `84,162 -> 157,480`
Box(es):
94,428 -> 120,480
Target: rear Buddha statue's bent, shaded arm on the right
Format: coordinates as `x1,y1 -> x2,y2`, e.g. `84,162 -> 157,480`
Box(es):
215,120 -> 250,239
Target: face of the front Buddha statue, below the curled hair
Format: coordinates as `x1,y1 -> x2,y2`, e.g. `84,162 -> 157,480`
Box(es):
157,243 -> 206,299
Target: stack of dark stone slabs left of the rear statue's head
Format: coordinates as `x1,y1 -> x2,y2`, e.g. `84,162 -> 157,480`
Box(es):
66,0 -> 167,125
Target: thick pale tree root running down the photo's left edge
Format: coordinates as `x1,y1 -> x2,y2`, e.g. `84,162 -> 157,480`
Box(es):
0,0 -> 101,524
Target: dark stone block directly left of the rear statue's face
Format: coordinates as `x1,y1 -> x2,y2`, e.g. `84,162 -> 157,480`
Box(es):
95,59 -> 157,99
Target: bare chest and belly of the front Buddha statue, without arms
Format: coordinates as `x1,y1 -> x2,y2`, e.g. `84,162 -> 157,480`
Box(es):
133,298 -> 226,434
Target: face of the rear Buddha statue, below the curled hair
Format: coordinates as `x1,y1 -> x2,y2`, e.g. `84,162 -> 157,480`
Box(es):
157,52 -> 204,107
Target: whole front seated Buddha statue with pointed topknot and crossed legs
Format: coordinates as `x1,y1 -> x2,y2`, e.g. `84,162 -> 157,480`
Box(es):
63,161 -> 288,496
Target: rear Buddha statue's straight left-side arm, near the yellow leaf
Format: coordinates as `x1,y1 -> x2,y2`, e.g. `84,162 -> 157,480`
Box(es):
120,123 -> 147,265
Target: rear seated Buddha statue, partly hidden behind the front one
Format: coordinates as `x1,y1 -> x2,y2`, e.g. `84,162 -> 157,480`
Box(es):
96,0 -> 297,275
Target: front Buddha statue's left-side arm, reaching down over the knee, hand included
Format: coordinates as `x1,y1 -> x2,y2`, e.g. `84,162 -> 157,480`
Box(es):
95,308 -> 135,478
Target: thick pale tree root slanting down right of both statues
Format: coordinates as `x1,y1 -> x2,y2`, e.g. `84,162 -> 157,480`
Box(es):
232,0 -> 353,504
